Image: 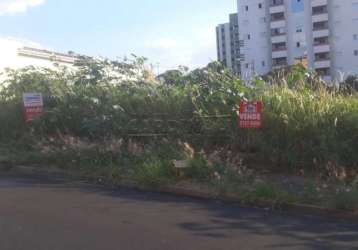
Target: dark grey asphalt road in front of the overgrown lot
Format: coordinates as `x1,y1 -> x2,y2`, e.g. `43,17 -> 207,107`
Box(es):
0,175 -> 358,250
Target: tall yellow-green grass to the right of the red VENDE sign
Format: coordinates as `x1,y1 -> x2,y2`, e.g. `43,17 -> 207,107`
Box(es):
259,86 -> 358,167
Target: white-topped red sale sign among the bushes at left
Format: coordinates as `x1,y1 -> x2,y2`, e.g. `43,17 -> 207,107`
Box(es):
23,93 -> 43,122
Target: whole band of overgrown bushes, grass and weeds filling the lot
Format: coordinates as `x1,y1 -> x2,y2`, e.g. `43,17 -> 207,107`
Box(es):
0,57 -> 358,208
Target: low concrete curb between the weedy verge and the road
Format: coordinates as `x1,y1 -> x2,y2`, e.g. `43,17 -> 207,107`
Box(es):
0,166 -> 358,223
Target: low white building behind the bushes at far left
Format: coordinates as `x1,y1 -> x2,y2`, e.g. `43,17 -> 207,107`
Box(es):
0,38 -> 77,71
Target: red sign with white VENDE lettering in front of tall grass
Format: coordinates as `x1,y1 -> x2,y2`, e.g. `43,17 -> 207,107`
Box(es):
239,102 -> 263,128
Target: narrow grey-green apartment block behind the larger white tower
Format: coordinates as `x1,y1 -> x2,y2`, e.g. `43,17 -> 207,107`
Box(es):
216,13 -> 241,74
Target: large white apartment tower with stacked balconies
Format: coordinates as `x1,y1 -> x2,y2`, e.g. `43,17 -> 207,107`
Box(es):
237,0 -> 358,80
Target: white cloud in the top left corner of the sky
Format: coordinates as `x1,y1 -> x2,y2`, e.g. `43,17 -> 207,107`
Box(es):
0,0 -> 45,15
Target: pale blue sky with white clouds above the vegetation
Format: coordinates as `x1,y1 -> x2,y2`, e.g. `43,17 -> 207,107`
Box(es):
0,0 -> 236,71
